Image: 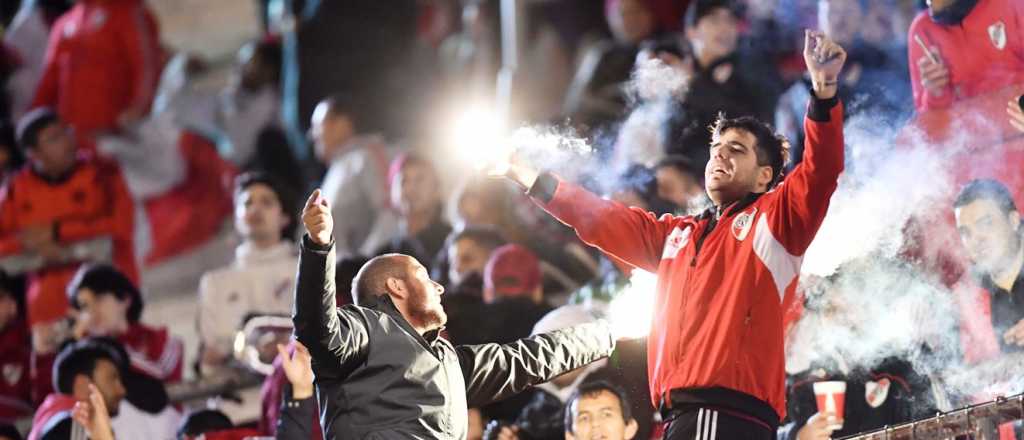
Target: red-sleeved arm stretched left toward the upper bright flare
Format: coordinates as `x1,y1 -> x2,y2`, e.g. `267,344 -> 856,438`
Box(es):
506,164 -> 681,273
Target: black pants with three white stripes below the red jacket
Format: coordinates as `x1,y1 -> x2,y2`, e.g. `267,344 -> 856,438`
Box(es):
665,408 -> 777,440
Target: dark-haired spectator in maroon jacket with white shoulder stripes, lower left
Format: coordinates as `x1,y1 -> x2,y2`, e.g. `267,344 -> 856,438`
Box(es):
68,265 -> 183,383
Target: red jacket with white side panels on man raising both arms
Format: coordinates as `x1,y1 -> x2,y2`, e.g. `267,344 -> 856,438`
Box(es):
543,98 -> 844,419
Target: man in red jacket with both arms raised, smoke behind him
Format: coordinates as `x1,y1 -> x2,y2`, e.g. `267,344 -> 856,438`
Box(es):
497,31 -> 846,440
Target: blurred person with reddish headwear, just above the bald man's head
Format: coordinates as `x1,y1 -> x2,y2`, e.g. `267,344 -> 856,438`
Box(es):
376,153 -> 452,269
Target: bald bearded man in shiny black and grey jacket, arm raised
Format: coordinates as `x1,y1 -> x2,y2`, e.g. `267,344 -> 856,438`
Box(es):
293,189 -> 614,440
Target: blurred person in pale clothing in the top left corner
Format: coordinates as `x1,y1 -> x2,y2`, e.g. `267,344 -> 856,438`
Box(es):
3,0 -> 72,120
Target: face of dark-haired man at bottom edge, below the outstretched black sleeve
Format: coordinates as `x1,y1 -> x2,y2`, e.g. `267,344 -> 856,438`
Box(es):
565,390 -> 637,440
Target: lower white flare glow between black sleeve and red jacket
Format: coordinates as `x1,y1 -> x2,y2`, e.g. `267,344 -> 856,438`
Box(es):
608,269 -> 657,338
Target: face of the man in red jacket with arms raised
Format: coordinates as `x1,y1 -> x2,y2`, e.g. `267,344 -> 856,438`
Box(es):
705,129 -> 771,206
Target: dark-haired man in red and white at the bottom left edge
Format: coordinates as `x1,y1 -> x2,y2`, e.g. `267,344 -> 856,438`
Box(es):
29,340 -> 127,440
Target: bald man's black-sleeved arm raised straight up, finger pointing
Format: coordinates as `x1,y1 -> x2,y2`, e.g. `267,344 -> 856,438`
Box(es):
292,189 -> 369,380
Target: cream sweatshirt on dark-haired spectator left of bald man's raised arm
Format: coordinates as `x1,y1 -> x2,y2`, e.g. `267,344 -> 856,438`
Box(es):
199,241 -> 299,353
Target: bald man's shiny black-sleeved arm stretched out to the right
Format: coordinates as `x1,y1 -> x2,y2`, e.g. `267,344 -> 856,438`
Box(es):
456,321 -> 615,407
